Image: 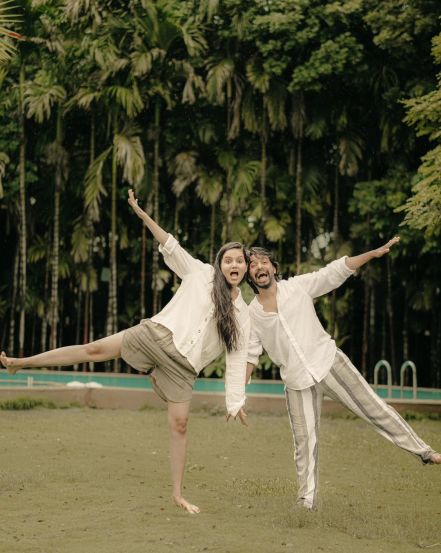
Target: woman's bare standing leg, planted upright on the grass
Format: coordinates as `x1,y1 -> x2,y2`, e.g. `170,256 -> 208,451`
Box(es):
167,401 -> 200,514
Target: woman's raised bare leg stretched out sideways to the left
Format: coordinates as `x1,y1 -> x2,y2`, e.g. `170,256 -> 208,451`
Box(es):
0,330 -> 125,374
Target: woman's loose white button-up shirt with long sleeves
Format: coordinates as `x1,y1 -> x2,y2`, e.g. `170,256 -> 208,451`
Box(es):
152,234 -> 250,416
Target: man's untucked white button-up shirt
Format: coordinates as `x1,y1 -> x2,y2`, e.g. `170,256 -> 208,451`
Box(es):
248,257 -> 355,390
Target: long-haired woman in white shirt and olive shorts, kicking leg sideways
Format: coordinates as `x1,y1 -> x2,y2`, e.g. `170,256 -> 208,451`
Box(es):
0,190 -> 250,514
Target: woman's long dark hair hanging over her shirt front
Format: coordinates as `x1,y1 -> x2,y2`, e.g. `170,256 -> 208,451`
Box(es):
211,242 -> 248,352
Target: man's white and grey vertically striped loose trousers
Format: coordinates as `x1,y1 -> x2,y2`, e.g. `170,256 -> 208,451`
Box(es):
285,350 -> 434,508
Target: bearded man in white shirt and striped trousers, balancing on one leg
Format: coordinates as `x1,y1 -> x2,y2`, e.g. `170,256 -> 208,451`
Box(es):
247,237 -> 441,509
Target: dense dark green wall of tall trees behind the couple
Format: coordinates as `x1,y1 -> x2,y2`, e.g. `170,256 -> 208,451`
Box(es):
0,0 -> 441,386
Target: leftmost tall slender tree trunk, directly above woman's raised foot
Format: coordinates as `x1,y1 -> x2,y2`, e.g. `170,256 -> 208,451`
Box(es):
18,63 -> 27,357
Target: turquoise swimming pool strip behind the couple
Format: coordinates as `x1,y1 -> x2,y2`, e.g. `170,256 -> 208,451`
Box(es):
0,370 -> 441,401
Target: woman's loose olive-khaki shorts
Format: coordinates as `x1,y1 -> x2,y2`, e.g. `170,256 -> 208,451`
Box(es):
121,319 -> 197,403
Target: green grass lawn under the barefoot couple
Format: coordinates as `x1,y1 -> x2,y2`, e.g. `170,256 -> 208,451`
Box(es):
0,402 -> 441,553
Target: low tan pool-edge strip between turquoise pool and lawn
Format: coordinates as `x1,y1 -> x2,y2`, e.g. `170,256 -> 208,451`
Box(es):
0,375 -> 441,415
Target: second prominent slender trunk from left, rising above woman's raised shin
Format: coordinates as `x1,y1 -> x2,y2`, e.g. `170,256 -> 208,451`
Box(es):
49,107 -> 62,349
